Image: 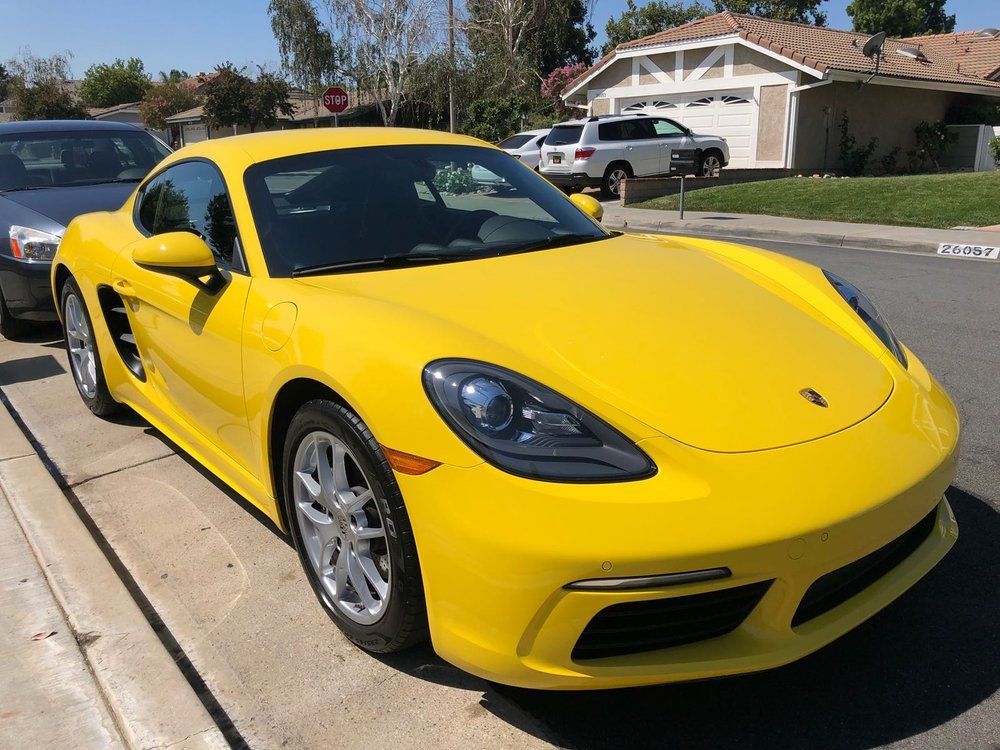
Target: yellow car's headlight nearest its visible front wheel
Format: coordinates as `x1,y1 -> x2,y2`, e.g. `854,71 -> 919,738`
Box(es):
424,359 -> 656,482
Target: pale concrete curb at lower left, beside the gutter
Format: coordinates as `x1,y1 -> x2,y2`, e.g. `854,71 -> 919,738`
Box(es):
0,404 -> 229,748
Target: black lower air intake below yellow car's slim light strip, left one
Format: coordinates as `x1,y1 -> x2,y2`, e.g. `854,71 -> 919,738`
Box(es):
573,581 -> 772,661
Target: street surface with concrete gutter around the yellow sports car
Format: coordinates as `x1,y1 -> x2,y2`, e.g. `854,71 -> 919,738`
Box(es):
0,243 -> 1000,750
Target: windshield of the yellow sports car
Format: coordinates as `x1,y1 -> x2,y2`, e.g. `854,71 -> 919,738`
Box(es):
245,146 -> 611,277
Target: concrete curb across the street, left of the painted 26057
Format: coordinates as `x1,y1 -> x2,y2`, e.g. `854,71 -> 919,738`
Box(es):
603,216 -> 938,255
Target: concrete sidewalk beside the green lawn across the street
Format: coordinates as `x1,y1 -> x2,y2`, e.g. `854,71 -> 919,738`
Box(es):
603,202 -> 1000,254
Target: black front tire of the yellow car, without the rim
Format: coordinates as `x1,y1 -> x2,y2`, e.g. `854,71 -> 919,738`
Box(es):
281,399 -> 428,654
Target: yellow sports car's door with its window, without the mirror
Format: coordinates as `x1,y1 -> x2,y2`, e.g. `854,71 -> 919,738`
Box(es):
112,159 -> 258,475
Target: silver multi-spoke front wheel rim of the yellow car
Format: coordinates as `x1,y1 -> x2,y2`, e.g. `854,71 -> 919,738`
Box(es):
292,431 -> 392,625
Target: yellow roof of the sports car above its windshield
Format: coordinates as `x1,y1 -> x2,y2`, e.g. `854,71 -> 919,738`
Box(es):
164,127 -> 496,165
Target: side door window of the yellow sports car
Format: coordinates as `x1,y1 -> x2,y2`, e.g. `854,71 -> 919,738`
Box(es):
139,161 -> 236,268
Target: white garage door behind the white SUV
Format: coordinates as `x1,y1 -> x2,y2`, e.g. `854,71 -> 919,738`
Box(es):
620,89 -> 757,169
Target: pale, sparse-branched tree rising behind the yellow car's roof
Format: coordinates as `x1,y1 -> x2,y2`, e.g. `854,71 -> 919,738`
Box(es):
327,0 -> 436,125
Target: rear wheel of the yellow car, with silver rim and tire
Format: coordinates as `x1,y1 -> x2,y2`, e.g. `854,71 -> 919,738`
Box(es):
60,279 -> 121,417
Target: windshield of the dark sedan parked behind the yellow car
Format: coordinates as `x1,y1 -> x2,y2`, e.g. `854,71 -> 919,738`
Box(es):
0,130 -> 170,190
